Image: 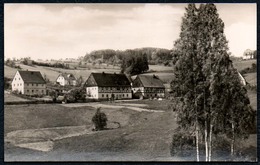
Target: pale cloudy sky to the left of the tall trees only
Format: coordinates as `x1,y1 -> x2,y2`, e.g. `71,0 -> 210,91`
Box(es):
5,4 -> 186,59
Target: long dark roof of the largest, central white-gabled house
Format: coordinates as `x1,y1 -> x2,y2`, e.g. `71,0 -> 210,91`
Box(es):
91,72 -> 131,87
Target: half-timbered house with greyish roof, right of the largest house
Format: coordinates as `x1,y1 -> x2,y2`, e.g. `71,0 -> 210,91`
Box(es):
132,75 -> 165,98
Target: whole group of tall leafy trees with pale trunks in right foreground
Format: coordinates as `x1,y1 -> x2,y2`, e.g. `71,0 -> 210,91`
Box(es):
171,4 -> 255,161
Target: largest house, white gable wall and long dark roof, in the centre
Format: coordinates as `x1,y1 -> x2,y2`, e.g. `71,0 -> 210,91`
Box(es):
84,72 -> 132,100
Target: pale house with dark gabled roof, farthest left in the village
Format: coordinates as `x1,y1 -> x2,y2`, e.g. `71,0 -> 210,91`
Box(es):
12,71 -> 46,95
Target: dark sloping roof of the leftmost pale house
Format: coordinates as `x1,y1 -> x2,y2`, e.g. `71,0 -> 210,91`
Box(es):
18,71 -> 46,84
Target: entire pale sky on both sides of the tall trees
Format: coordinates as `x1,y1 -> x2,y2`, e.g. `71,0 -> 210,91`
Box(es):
4,3 -> 257,60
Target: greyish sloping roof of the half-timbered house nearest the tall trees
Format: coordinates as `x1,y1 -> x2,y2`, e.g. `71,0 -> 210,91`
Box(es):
136,75 -> 165,88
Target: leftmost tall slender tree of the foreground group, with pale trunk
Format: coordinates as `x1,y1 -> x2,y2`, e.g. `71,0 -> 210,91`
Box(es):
171,4 -> 202,161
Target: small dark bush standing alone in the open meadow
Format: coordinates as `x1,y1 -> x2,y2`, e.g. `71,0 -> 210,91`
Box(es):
92,107 -> 107,131
